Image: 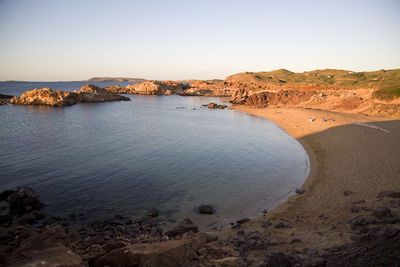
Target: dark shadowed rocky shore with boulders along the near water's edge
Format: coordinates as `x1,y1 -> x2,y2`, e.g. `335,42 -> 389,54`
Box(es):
0,187 -> 400,266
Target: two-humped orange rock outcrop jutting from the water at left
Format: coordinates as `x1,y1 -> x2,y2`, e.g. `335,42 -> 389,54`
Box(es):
9,84 -> 130,107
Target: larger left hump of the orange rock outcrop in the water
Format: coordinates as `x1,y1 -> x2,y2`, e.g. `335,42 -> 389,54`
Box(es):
9,88 -> 77,107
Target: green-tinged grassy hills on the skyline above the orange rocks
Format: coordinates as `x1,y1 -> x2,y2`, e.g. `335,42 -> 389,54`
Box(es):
225,69 -> 400,88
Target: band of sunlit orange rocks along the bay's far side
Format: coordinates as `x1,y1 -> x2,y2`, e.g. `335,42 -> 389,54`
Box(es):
0,79 -> 400,117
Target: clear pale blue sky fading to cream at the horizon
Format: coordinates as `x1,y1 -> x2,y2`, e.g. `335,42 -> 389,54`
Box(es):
0,0 -> 400,81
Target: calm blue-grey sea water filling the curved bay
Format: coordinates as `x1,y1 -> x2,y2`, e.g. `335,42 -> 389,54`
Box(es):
0,82 -> 309,229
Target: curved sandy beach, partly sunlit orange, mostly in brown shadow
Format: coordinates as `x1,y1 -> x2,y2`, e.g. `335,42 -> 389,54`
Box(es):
228,106 -> 400,251
